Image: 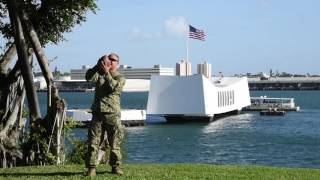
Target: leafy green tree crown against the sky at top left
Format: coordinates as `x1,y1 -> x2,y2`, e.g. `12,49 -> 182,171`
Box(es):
0,0 -> 97,45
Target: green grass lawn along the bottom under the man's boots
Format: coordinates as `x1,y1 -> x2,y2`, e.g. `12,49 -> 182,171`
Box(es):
0,164 -> 320,180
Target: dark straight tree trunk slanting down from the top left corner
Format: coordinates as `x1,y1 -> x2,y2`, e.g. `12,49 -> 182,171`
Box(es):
7,0 -> 41,122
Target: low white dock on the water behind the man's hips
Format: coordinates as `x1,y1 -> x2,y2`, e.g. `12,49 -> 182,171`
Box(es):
67,109 -> 146,127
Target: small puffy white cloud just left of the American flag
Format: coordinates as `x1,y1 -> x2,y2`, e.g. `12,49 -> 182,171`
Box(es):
164,16 -> 188,36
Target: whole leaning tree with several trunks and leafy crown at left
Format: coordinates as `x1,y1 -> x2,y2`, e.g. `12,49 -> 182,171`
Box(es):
0,0 -> 97,167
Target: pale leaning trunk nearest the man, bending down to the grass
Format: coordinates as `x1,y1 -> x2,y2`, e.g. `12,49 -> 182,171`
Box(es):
19,1 -> 66,164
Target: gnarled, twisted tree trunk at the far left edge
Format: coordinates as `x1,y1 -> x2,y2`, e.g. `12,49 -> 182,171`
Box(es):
0,70 -> 25,168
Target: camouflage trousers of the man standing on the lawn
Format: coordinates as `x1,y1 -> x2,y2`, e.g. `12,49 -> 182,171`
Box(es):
86,113 -> 124,168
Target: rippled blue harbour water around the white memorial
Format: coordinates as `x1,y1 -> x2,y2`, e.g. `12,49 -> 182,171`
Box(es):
40,91 -> 320,168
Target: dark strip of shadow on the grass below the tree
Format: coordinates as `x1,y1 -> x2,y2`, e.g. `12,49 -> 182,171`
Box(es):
0,171 -> 111,177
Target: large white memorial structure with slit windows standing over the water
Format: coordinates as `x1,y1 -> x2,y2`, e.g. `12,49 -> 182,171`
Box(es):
147,74 -> 250,121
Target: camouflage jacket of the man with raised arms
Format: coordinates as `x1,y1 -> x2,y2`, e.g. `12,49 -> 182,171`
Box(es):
86,65 -> 125,113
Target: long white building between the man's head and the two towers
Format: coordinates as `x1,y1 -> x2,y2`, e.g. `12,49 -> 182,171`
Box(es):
118,65 -> 174,79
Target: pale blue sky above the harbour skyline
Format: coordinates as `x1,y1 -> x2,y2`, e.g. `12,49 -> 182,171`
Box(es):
5,0 -> 320,75
